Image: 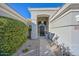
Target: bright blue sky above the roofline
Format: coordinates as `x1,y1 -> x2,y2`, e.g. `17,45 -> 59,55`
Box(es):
8,3 -> 64,18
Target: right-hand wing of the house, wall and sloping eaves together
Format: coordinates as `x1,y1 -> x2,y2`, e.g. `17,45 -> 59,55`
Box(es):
49,4 -> 79,55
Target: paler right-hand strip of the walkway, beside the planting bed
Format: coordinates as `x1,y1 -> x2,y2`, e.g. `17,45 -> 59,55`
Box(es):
40,38 -> 54,56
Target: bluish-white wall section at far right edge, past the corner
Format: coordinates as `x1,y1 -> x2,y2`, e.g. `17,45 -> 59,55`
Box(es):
71,11 -> 79,55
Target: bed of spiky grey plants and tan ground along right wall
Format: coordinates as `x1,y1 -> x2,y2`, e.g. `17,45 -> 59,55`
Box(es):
48,32 -> 73,56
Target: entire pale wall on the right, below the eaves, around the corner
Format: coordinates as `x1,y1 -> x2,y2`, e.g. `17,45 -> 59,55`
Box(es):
49,11 -> 79,55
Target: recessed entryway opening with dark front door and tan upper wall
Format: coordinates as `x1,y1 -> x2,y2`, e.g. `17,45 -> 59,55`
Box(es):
37,15 -> 49,36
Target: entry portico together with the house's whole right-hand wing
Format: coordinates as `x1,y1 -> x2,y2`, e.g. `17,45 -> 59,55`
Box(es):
29,4 -> 79,55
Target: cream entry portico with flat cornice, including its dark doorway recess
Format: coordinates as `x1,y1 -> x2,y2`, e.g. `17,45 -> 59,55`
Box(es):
28,8 -> 60,39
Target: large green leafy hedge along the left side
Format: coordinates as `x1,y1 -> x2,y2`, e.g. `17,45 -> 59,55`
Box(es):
0,16 -> 28,56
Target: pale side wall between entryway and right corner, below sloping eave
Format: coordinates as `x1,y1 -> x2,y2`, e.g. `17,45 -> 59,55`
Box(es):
49,13 -> 72,46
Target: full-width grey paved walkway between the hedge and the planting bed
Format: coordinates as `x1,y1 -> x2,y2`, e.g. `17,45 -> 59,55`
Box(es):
14,38 -> 54,56
